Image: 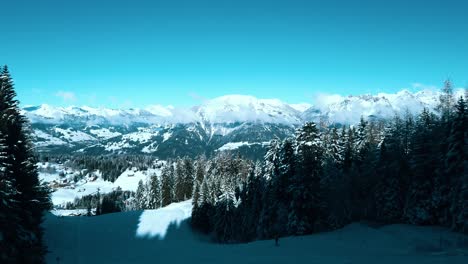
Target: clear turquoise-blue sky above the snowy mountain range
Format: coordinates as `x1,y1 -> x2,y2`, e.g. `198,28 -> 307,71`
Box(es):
0,0 -> 468,107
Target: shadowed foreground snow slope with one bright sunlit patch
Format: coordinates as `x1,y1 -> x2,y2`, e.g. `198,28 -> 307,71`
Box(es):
44,201 -> 468,264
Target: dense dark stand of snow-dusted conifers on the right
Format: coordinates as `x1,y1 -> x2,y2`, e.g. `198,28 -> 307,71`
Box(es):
192,82 -> 468,243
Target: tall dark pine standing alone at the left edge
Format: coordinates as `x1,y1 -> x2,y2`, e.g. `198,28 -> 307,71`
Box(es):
0,66 -> 51,263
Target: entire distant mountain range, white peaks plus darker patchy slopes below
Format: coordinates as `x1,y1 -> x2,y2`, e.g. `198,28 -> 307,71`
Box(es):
23,90 -> 463,158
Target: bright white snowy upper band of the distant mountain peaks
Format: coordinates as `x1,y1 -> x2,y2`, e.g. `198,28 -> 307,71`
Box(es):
23,89 -> 464,125
